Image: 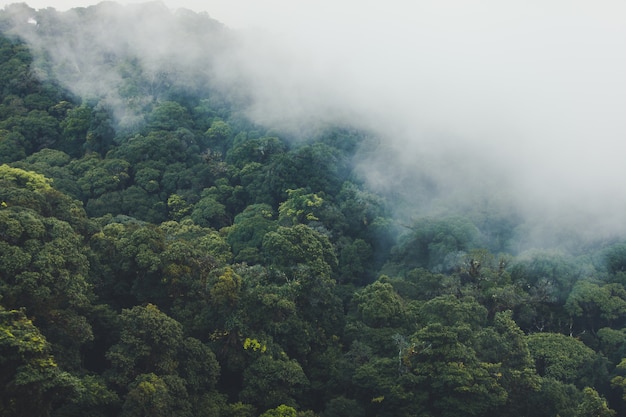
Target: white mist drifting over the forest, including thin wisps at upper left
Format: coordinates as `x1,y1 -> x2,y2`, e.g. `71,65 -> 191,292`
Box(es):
3,0 -> 626,246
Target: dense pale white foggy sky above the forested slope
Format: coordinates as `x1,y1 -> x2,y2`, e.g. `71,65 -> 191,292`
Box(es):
0,0 -> 626,244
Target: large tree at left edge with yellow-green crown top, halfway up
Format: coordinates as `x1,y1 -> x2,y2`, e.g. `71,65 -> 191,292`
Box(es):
0,171 -> 93,369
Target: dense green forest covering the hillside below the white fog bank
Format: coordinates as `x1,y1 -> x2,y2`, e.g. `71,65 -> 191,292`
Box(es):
0,2 -> 626,417
